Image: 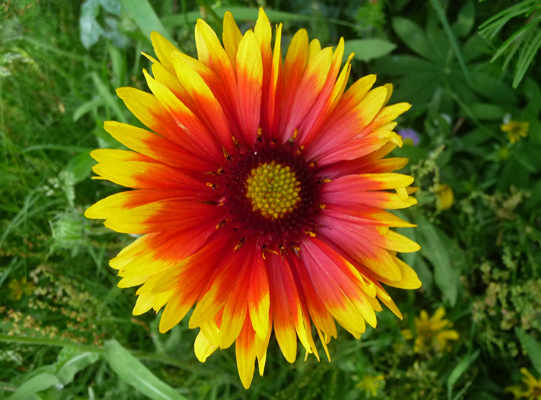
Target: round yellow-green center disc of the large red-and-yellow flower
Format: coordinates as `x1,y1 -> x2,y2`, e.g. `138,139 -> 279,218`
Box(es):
246,161 -> 301,219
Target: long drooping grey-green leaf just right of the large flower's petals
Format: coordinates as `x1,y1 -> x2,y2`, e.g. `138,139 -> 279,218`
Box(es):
415,216 -> 458,306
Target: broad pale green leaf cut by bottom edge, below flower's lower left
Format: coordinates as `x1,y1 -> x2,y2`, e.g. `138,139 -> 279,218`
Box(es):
104,340 -> 186,400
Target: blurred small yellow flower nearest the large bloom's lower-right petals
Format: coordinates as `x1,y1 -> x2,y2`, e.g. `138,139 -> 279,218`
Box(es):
402,307 -> 460,353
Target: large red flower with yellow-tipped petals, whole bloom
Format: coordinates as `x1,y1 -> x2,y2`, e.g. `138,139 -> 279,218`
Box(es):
86,9 -> 421,388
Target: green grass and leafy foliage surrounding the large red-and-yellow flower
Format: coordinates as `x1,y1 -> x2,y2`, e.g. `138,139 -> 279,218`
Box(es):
0,0 -> 541,400
